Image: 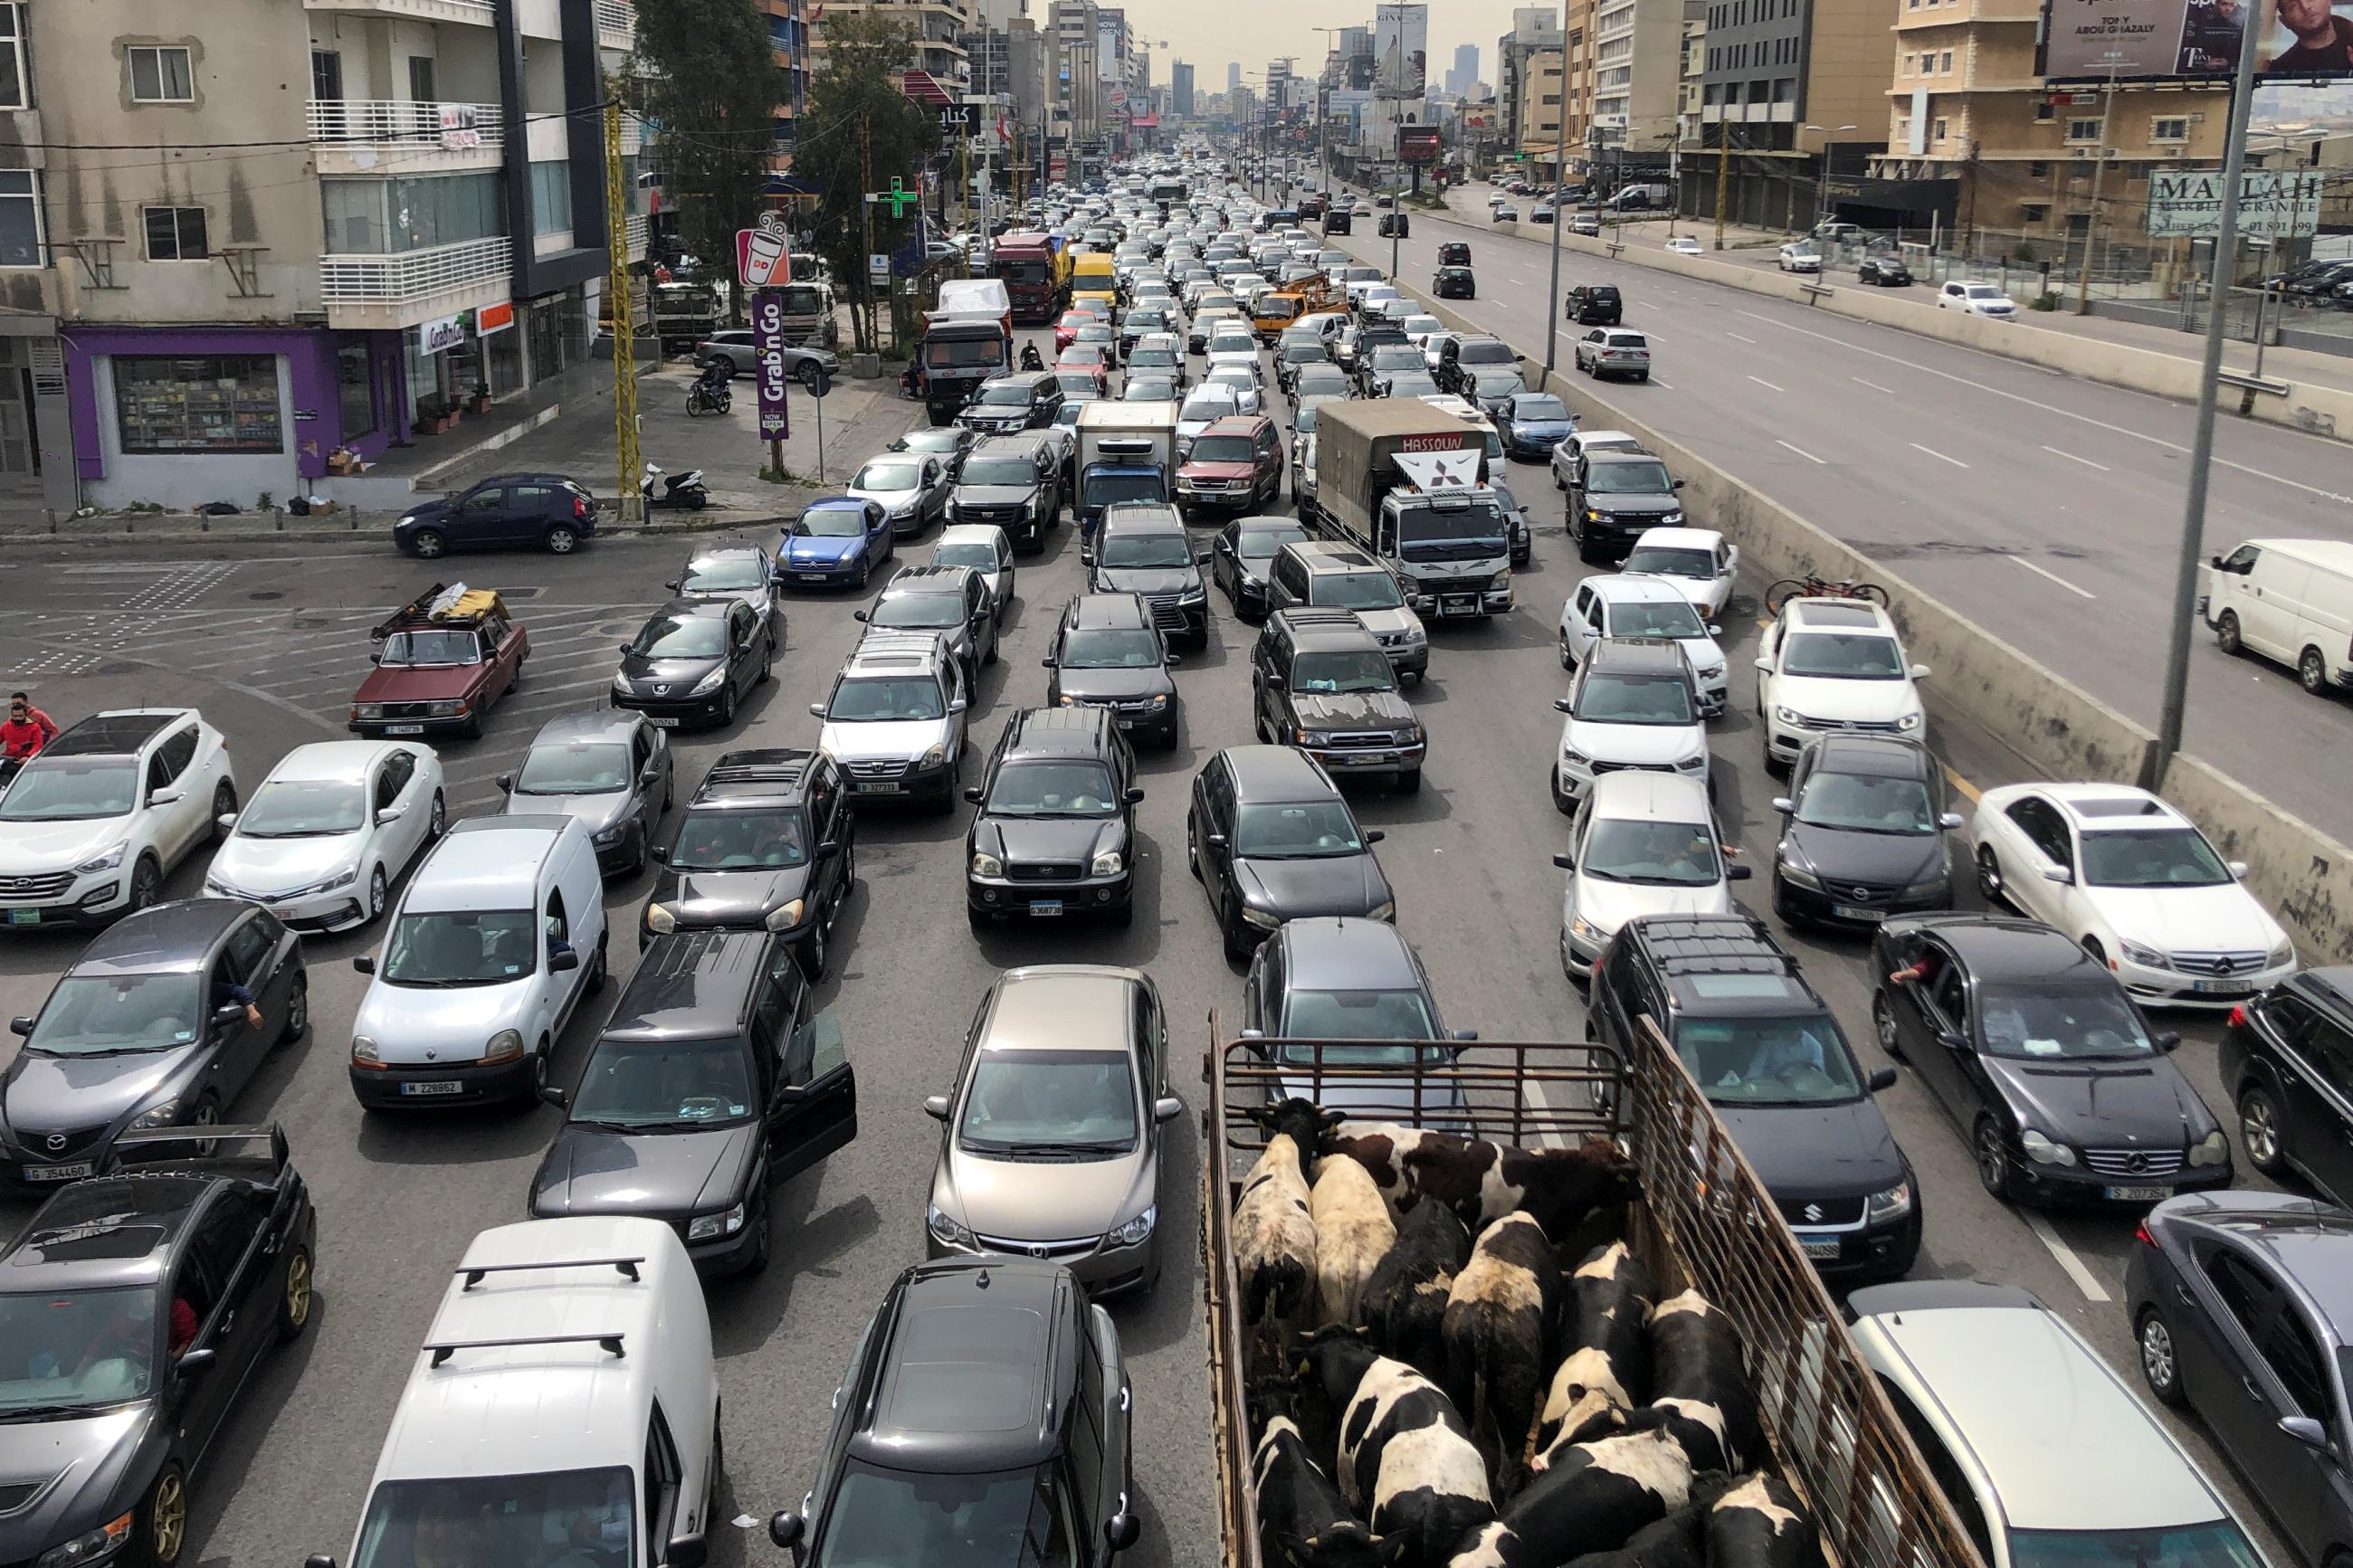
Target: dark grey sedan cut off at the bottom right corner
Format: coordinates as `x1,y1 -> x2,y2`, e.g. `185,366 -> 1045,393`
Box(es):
2125,1192 -> 2353,1563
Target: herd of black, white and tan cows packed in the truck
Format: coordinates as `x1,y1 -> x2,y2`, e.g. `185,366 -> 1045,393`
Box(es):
1233,1098 -> 1824,1568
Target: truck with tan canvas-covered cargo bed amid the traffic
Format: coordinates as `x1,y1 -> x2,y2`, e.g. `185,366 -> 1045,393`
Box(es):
1315,397 -> 1510,621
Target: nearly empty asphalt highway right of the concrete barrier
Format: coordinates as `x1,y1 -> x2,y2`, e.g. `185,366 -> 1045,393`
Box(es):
1337,195 -> 2353,860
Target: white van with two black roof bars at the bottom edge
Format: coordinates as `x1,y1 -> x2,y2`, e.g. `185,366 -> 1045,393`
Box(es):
322,1215 -> 720,1568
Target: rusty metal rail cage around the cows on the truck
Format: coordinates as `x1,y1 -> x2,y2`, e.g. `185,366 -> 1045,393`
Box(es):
1200,1013 -> 1979,1568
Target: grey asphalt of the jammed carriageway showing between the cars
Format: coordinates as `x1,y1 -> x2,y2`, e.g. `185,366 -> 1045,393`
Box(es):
0,309 -> 2287,1568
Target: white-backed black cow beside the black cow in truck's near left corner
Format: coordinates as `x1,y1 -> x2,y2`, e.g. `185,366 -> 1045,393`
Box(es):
1303,1324 -> 1494,1568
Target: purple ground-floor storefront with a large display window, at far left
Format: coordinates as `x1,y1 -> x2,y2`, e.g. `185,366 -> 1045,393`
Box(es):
62,327 -> 409,510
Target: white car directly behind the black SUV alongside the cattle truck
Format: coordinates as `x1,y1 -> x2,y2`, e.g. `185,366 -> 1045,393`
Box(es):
1553,769 -> 1748,980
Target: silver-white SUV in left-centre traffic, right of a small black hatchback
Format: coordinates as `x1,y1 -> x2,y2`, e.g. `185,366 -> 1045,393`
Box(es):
809,630 -> 967,811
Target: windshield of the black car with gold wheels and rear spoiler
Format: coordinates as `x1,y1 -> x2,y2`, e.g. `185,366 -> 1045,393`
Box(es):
0,1297 -> 162,1420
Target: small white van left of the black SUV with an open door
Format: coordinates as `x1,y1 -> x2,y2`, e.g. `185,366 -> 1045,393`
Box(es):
350,813 -> 605,1109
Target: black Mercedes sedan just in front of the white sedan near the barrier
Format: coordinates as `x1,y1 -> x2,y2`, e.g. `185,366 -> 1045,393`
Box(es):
1871,915 -> 2231,1206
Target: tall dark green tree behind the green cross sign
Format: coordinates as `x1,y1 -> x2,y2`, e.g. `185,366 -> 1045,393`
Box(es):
793,12 -> 938,350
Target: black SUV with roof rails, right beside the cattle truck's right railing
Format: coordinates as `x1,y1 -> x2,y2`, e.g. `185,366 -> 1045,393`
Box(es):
1586,915 -> 1920,1278
